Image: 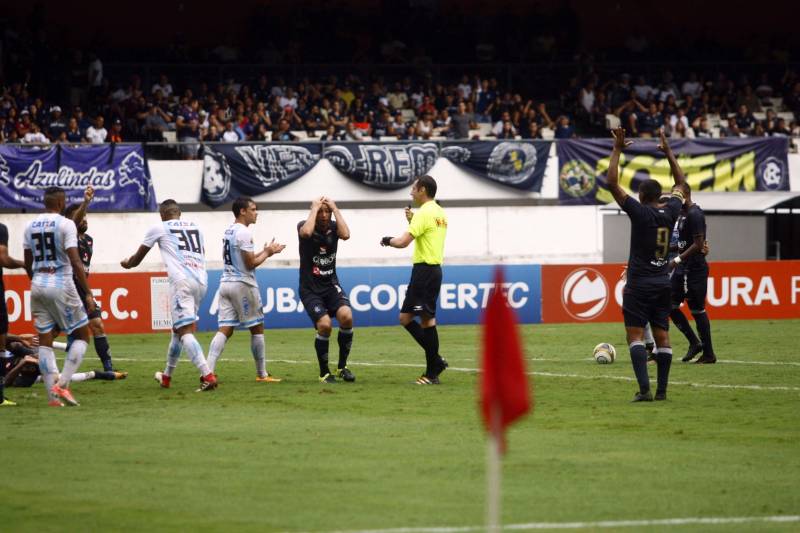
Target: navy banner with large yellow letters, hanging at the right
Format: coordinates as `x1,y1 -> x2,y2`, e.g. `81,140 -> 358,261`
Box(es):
557,137 -> 789,205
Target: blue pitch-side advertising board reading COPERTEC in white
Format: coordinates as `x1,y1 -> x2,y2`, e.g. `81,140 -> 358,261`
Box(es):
198,265 -> 542,331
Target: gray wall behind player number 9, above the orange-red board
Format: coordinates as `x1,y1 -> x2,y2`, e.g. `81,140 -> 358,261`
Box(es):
603,213 -> 767,263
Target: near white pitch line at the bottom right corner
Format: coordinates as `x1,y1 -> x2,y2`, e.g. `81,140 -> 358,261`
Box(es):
308,515 -> 800,533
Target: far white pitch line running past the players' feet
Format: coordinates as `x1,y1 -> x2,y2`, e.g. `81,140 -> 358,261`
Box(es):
101,357 -> 800,392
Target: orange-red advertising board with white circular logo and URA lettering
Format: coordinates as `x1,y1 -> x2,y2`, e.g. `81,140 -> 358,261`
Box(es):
542,261 -> 800,323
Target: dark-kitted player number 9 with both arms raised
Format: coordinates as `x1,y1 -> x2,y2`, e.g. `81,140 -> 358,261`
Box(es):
608,127 -> 686,402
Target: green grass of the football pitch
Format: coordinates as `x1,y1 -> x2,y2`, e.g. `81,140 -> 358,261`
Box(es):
0,320 -> 800,532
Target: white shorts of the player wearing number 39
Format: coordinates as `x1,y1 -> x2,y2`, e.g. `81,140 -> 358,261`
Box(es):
31,279 -> 89,334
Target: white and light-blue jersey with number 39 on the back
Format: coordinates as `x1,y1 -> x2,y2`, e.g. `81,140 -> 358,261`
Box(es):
22,213 -> 78,288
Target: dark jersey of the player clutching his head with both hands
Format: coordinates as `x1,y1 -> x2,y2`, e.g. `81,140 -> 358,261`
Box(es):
297,220 -> 339,292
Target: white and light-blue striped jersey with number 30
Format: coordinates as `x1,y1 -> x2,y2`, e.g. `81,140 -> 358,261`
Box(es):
142,219 -> 208,285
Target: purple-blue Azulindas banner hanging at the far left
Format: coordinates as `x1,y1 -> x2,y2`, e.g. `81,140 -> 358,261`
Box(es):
0,144 -> 156,211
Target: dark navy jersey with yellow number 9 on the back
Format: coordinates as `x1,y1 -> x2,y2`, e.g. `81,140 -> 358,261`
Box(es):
622,196 -> 682,286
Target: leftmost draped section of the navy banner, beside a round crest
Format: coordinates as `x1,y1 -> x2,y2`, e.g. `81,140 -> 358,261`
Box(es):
203,143 -> 322,207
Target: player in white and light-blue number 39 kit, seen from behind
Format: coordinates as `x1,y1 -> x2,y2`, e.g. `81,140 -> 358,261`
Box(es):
23,187 -> 95,406
